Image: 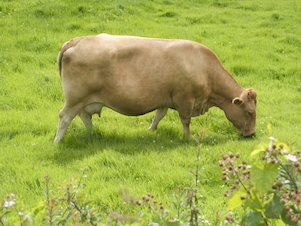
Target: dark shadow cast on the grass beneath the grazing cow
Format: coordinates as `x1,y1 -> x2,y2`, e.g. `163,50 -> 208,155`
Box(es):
54,124 -> 237,165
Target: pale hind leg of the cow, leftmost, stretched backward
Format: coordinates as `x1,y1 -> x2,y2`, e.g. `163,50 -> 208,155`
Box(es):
54,105 -> 81,143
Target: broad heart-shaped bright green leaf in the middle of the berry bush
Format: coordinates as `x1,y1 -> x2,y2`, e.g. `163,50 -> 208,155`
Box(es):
251,164 -> 278,194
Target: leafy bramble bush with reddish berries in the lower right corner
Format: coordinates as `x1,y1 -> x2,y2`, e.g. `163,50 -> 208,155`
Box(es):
219,137 -> 301,225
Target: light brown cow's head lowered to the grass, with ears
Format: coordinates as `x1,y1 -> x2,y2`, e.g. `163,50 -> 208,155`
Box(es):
225,88 -> 256,137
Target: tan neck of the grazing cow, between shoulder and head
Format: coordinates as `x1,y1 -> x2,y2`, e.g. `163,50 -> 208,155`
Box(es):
209,70 -> 243,111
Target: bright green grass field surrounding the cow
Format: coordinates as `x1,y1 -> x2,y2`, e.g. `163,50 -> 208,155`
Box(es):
0,0 -> 301,222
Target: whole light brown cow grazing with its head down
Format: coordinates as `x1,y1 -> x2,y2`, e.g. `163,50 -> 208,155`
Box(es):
54,34 -> 256,142
